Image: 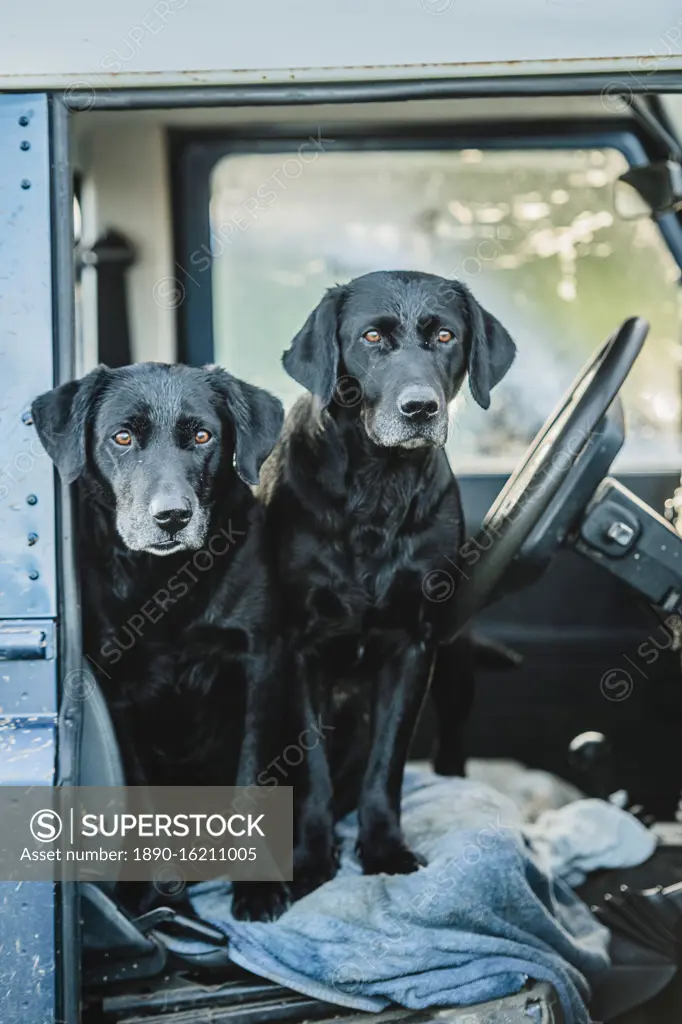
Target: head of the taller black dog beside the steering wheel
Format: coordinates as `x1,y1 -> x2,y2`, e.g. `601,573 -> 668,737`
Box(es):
284,271 -> 515,449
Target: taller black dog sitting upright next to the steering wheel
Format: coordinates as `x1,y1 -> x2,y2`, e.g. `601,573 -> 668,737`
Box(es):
262,271 -> 515,894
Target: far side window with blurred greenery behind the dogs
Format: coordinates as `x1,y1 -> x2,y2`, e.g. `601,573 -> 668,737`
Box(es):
210,147 -> 682,472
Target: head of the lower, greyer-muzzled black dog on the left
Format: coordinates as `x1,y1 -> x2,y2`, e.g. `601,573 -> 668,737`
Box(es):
33,362 -> 283,555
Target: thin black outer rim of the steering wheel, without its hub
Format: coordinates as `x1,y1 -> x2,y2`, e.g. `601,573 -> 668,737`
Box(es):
455,316 -> 649,633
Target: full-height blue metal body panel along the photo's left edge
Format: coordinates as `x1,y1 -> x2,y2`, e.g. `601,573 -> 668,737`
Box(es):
0,95 -> 57,1024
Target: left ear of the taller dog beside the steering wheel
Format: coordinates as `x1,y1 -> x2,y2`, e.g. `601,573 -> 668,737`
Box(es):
282,287 -> 345,409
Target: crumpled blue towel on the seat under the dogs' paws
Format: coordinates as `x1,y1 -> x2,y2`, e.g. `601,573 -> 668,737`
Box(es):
188,769 -> 648,1024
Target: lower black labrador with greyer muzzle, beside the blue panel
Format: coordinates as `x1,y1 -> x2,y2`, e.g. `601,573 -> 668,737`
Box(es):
33,364 -> 284,916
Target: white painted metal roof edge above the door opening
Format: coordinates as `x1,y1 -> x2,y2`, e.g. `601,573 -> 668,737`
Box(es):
0,0 -> 682,90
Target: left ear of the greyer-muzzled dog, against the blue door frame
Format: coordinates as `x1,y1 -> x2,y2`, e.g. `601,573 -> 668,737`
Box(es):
31,366 -> 108,483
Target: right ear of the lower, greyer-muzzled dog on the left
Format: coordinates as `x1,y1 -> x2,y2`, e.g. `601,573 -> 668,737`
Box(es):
209,367 -> 284,485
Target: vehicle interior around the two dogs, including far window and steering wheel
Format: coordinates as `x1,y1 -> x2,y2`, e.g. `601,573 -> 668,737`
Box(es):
35,92 -> 682,1024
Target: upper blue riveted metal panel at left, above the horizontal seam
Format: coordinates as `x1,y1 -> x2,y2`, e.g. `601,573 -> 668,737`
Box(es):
0,96 -> 56,620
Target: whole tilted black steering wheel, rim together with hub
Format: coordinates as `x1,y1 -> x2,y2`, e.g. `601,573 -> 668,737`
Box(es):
455,317 -> 649,633
